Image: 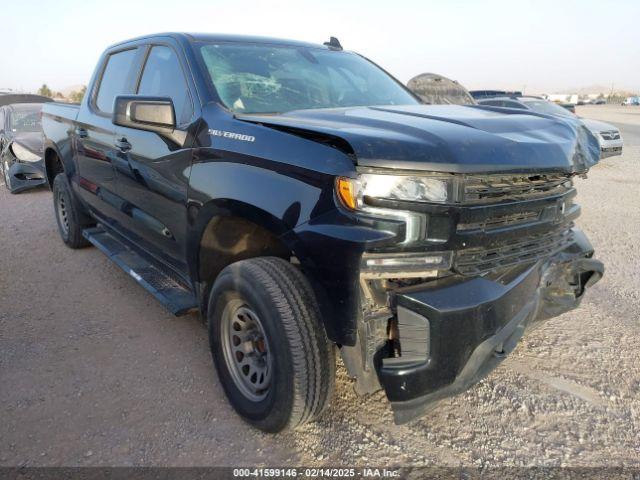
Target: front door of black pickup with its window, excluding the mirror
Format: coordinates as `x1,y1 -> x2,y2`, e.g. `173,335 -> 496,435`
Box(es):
116,41 -> 196,273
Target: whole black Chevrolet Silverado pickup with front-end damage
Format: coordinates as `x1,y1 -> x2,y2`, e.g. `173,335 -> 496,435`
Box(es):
43,34 -> 603,432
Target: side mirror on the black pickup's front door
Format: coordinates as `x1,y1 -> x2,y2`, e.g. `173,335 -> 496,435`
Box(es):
112,95 -> 176,135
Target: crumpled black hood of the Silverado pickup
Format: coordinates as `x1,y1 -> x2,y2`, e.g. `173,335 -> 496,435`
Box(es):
237,105 -> 600,173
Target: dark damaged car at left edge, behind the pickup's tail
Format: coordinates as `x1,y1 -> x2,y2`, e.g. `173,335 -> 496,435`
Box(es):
0,103 -> 47,193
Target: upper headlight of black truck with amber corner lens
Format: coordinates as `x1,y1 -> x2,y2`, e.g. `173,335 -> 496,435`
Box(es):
337,173 -> 451,210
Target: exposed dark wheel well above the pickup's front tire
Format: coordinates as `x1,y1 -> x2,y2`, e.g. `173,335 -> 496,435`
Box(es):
198,216 -> 293,292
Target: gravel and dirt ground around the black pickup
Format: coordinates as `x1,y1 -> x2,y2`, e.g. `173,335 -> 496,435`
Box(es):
0,106 -> 640,467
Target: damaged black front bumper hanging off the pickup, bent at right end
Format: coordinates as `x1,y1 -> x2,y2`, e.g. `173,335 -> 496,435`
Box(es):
375,230 -> 604,423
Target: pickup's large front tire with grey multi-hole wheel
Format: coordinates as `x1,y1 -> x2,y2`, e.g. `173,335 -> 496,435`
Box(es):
207,257 -> 335,432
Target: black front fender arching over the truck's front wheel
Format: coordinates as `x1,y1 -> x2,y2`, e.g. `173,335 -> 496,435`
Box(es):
187,111 -> 364,343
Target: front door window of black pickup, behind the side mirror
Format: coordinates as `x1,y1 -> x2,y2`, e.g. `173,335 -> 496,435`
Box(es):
138,45 -> 193,124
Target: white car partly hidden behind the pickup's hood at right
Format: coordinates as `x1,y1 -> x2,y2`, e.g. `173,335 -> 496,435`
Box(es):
478,96 -> 624,158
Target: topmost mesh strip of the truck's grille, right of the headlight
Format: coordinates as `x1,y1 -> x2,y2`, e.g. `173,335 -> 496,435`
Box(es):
463,174 -> 572,203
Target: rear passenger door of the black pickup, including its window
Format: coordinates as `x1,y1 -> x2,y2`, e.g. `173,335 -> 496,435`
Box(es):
73,47 -> 140,223
